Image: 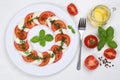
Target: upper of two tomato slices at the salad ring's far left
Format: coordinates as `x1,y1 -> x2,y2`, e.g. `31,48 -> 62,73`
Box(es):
15,26 -> 28,40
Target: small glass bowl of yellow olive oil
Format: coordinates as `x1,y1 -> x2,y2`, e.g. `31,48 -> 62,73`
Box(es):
88,5 -> 110,26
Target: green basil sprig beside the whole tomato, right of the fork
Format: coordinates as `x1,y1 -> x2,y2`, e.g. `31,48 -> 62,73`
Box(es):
97,26 -> 117,51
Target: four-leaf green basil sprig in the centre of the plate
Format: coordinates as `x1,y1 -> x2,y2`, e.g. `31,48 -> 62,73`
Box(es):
31,29 -> 53,47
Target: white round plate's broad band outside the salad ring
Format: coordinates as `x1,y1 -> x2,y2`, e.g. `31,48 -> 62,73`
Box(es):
6,3 -> 79,76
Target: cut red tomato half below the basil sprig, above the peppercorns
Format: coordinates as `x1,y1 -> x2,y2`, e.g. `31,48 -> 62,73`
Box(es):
104,48 -> 117,59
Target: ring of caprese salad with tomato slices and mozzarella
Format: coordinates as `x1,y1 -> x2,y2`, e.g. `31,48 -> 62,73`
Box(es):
14,11 -> 71,66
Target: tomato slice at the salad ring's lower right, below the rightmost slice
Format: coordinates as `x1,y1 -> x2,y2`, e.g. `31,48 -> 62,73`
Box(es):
51,45 -> 62,63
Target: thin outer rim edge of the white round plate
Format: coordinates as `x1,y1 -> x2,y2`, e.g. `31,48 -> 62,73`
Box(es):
5,3 -> 79,76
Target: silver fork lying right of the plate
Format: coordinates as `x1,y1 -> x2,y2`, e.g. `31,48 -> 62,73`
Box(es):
77,18 -> 86,70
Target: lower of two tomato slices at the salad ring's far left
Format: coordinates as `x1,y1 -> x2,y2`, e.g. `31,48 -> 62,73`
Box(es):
14,41 -> 29,52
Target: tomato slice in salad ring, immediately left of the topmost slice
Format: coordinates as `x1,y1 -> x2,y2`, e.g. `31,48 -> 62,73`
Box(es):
25,13 -> 37,29
